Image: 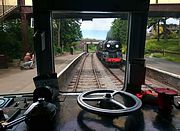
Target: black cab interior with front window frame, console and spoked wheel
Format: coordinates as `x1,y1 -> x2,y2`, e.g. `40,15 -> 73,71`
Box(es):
0,0 -> 180,131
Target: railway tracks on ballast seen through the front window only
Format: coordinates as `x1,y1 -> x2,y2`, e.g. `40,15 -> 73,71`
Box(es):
67,53 -> 124,92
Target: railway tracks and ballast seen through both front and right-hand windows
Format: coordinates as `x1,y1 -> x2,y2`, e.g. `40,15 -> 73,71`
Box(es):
59,54 -> 179,92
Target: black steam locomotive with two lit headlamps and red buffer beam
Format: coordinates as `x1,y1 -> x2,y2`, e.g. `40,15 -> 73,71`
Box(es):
96,40 -> 123,67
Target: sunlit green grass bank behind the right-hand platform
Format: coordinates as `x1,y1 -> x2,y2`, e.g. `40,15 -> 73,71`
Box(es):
145,39 -> 180,62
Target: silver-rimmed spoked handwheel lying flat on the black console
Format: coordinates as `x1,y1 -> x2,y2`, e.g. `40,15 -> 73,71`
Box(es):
77,90 -> 142,116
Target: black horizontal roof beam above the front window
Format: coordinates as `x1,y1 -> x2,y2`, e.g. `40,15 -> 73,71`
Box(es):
33,0 -> 149,12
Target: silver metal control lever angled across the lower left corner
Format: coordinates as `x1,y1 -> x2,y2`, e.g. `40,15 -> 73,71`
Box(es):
0,98 -> 41,131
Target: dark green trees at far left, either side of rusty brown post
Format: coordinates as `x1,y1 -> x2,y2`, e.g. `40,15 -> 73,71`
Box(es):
0,19 -> 33,59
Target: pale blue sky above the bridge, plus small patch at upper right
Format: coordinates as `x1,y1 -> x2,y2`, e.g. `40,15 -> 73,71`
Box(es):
81,18 -> 179,40
